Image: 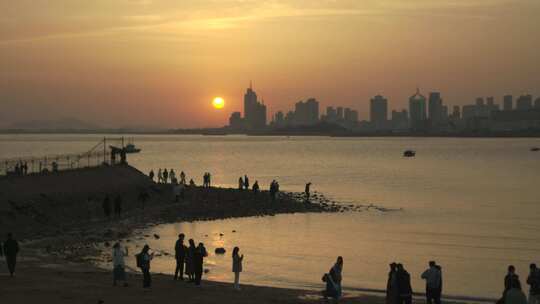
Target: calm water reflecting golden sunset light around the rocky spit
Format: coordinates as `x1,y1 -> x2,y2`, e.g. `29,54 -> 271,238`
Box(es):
0,135 -> 540,297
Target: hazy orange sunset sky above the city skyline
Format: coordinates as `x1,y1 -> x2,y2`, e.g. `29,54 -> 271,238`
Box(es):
0,0 -> 540,127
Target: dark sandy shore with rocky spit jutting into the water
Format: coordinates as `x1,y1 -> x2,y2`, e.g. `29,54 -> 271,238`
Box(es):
0,166 -> 382,303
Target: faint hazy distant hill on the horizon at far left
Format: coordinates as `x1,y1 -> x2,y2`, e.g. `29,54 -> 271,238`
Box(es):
7,118 -> 101,131
